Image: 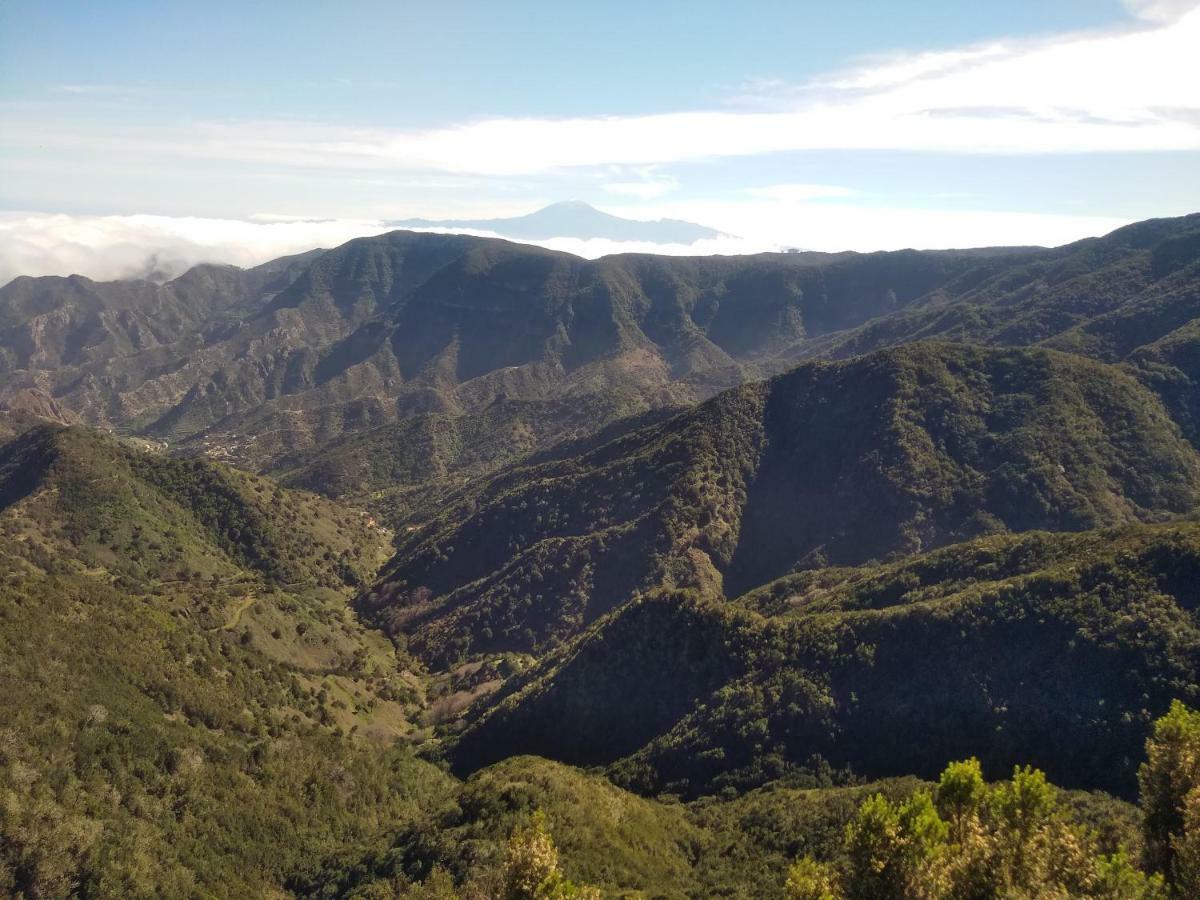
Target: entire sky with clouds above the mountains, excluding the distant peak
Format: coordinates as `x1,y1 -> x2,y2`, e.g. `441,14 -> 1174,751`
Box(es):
0,0 -> 1200,283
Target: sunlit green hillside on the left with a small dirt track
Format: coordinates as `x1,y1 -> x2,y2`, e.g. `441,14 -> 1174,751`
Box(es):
0,427 -> 456,896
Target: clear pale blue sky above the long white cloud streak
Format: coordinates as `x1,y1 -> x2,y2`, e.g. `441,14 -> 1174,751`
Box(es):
0,0 -> 1128,126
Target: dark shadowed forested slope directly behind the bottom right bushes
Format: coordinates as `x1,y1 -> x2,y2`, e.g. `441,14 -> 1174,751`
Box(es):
455,522 -> 1200,794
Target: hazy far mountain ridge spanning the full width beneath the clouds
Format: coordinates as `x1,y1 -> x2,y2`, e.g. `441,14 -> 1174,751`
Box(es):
0,216 -> 1200,520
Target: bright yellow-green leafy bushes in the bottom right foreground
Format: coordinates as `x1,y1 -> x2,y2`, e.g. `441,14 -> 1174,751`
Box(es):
785,702 -> 1200,900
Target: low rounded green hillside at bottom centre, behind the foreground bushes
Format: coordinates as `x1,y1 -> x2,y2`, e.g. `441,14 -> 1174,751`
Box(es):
297,756 -> 1141,900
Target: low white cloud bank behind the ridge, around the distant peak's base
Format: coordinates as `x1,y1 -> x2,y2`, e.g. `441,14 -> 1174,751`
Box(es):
0,204 -> 1126,284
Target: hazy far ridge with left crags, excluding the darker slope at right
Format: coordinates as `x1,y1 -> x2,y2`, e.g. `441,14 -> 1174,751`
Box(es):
0,225 -> 998,501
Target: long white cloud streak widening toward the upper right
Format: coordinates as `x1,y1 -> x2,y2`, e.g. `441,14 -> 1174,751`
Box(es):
5,0 -> 1200,176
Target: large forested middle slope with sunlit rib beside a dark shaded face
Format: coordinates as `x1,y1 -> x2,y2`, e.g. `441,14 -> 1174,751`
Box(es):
360,344 -> 1200,665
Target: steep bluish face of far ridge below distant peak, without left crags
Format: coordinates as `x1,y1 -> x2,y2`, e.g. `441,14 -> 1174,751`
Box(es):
159,233 -> 988,493
